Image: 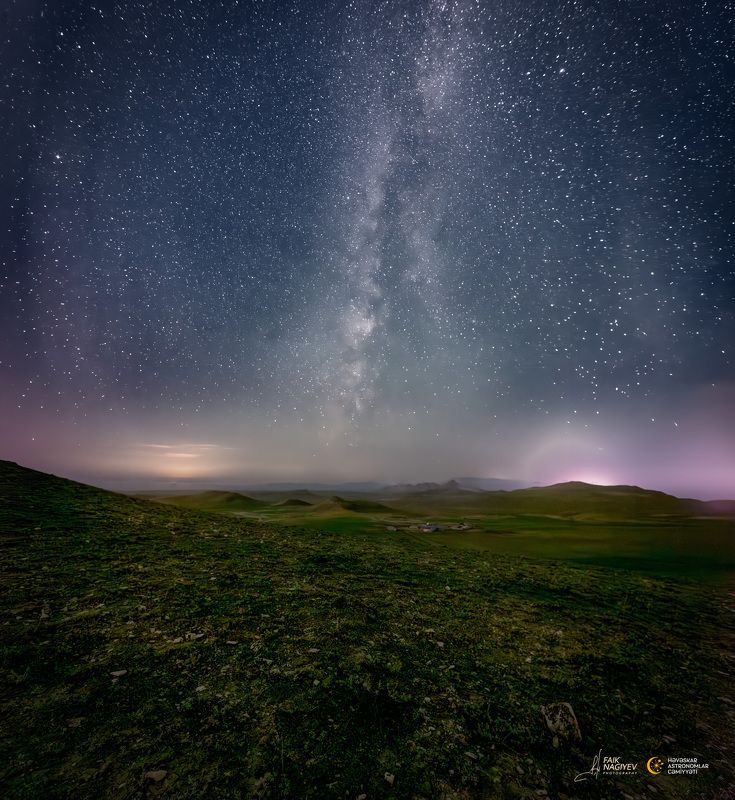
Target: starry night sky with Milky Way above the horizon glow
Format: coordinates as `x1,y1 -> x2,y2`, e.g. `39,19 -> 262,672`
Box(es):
0,0 -> 735,497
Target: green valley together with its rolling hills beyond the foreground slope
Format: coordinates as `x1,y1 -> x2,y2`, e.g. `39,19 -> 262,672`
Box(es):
144,484 -> 735,583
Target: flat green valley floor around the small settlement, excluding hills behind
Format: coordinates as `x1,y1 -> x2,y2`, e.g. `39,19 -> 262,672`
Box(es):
187,499 -> 735,583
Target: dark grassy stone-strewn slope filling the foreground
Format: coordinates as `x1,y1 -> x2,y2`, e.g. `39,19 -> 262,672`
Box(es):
0,463 -> 735,800
